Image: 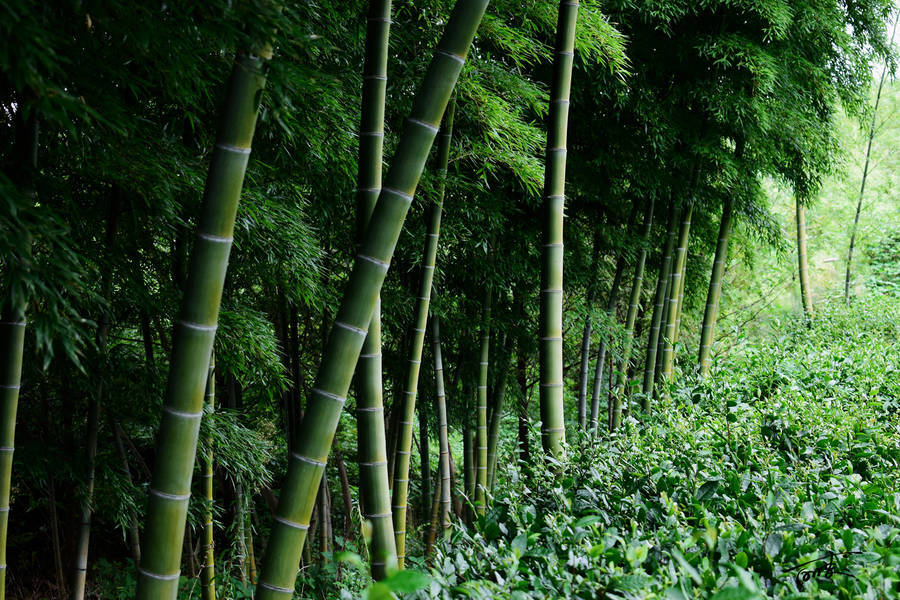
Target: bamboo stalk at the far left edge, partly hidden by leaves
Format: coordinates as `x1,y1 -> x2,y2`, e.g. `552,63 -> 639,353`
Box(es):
0,107 -> 39,600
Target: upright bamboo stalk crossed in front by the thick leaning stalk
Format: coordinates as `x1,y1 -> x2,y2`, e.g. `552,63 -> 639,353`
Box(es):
356,0 -> 397,580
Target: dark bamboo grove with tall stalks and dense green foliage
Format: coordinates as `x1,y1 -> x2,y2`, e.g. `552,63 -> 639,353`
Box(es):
0,0 -> 894,598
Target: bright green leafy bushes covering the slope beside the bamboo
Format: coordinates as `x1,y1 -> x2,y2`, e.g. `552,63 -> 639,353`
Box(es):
417,298 -> 900,600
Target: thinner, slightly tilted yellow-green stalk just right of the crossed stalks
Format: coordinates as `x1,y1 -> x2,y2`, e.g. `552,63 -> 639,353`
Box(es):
392,99 -> 456,569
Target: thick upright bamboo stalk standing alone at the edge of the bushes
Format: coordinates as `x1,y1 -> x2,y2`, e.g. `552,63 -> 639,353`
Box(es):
540,0 -> 578,456
